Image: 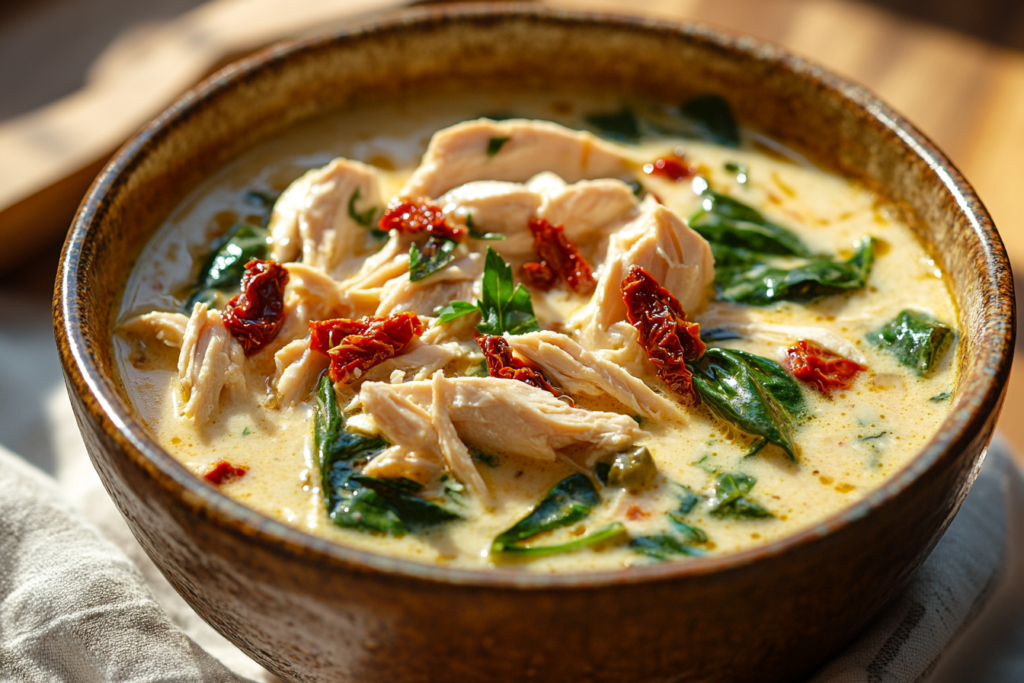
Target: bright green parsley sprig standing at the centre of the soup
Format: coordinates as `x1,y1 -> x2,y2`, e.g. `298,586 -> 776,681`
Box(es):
434,247 -> 541,335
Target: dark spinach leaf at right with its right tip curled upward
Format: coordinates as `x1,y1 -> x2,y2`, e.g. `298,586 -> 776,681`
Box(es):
715,238 -> 874,306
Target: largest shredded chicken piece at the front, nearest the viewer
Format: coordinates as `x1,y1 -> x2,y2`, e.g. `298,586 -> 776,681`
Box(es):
358,376 -> 649,466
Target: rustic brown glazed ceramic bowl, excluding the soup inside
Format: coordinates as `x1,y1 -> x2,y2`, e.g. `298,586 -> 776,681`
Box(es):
54,6 -> 1014,683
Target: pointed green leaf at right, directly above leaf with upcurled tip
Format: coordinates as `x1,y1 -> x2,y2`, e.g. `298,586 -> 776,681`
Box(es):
689,189 -> 811,262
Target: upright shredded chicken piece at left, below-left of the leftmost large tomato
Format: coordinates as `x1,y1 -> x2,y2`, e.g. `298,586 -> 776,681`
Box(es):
175,303 -> 246,426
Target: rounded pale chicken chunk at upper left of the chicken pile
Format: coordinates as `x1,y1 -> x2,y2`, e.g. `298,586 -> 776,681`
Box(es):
268,159 -> 383,278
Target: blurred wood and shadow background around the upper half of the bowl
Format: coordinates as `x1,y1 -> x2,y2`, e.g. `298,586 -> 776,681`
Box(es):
0,0 -> 1024,462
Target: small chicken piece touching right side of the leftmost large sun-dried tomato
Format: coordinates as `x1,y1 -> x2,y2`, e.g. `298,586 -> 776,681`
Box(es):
279,263 -> 352,339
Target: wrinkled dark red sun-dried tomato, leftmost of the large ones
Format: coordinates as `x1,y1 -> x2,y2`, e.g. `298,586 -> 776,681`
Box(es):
224,259 -> 288,355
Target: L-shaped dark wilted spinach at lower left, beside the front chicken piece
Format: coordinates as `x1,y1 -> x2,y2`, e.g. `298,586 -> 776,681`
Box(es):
313,374 -> 459,536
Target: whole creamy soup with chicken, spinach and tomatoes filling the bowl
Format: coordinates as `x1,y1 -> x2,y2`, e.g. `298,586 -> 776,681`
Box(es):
114,93 -> 956,571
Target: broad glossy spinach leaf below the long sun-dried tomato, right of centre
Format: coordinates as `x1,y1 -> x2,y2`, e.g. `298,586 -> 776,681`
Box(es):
686,348 -> 806,461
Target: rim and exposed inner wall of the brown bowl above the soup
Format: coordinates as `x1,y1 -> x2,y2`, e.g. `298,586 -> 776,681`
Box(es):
61,2 -> 1014,586
